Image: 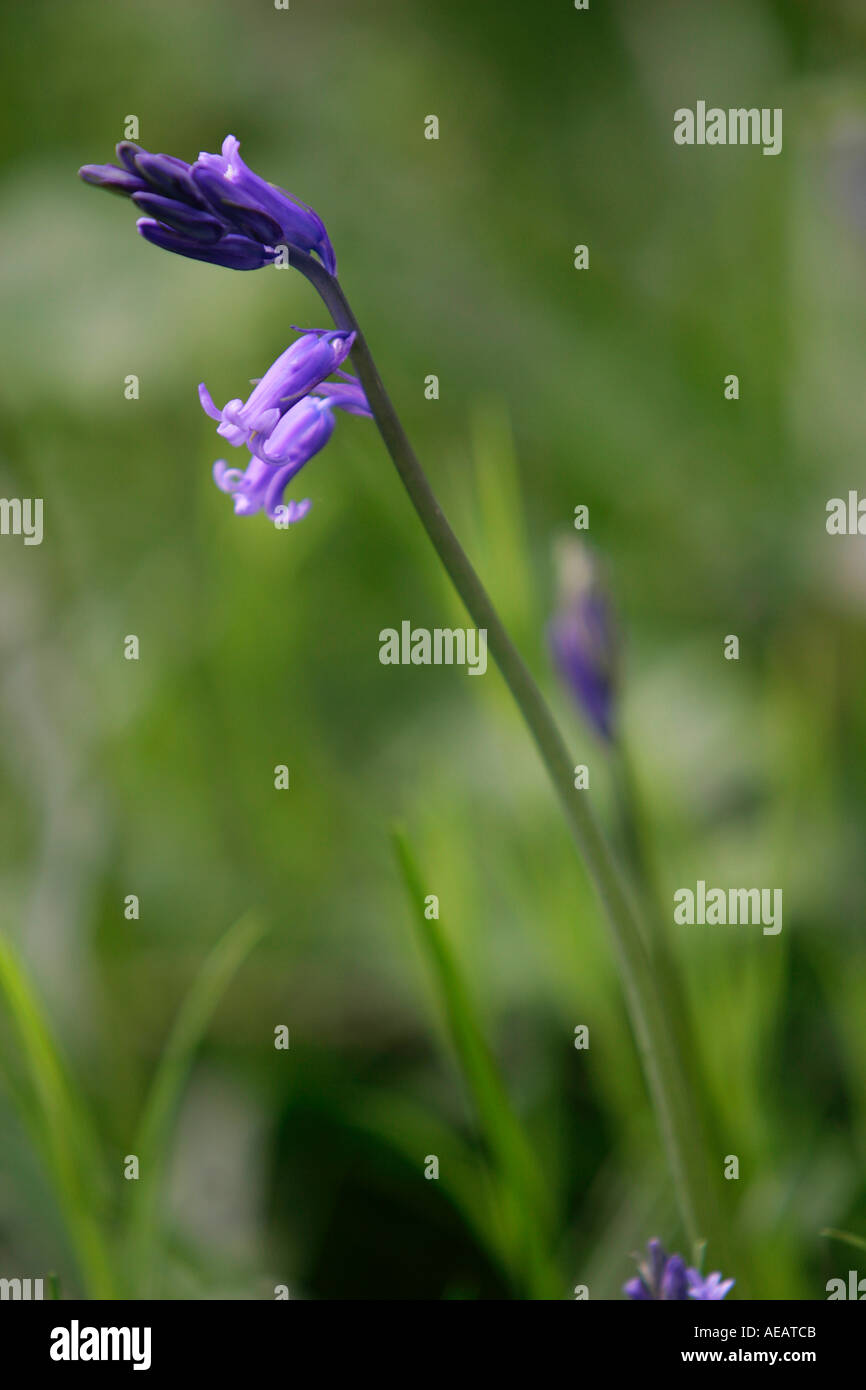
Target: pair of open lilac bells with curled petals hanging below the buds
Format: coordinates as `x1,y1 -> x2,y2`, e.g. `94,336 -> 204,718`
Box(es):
199,328 -> 370,524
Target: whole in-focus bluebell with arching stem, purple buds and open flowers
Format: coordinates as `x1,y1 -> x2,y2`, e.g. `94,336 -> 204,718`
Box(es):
81,135 -> 713,1262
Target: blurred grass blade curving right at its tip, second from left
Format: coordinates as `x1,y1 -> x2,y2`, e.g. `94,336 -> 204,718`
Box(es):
126,913 -> 265,1297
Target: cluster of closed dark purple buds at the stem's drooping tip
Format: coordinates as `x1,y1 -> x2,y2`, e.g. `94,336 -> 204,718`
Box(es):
79,135 -> 336,275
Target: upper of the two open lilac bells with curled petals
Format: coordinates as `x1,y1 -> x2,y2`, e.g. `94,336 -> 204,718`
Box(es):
199,329 -> 354,446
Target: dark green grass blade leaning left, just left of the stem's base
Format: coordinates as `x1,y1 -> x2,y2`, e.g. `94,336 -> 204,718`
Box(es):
393,831 -> 562,1298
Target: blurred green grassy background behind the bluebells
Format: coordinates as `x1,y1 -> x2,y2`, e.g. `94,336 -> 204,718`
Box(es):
0,0 -> 866,1300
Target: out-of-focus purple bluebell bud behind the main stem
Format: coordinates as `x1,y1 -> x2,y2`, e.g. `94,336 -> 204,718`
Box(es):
548,539 -> 617,739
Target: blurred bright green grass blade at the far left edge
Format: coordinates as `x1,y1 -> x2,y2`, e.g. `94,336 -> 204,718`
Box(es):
0,934 -> 115,1298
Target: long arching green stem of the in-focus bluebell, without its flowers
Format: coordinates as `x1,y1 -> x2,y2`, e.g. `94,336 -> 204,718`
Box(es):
289,250 -> 712,1244
